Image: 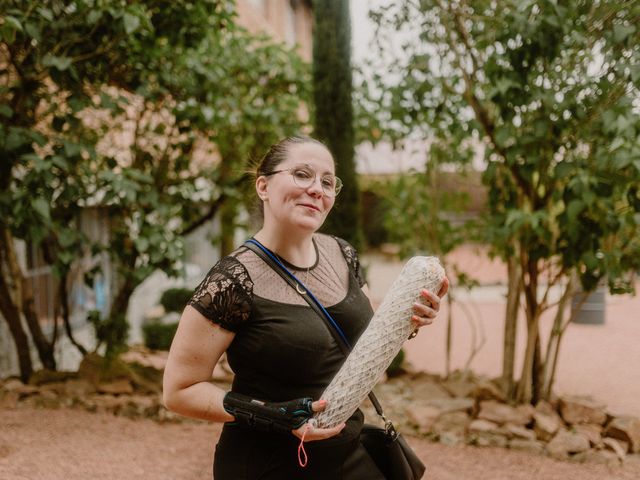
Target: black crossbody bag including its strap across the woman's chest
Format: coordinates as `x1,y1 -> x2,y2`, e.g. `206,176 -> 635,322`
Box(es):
244,238 -> 426,480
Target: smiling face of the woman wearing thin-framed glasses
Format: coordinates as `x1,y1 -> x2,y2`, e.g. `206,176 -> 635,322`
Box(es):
256,142 -> 335,232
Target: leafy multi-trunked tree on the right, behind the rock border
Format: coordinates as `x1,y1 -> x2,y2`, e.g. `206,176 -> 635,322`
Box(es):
364,0 -> 640,402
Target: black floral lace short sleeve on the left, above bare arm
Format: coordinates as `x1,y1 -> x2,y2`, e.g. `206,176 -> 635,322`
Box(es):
188,257 -> 253,332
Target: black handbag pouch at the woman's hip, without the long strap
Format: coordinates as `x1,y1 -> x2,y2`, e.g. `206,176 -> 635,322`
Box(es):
360,423 -> 426,480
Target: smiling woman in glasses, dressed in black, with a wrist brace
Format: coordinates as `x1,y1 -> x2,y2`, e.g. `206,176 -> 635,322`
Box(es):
164,137 -> 448,480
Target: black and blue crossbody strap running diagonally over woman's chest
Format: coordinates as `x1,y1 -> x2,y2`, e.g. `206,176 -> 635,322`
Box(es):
244,238 -> 388,422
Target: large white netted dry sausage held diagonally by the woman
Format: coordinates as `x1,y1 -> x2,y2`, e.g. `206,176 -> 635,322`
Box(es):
315,257 -> 445,428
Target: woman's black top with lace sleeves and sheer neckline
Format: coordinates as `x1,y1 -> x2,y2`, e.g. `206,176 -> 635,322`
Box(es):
189,234 -> 373,401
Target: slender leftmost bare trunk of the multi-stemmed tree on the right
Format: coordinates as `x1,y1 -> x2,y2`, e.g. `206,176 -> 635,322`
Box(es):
502,257 -> 522,399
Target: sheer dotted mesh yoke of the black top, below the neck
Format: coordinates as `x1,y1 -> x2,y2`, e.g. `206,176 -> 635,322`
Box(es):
237,234 -> 349,307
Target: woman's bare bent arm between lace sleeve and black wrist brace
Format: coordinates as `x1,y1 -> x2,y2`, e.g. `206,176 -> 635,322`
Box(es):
162,306 -> 235,422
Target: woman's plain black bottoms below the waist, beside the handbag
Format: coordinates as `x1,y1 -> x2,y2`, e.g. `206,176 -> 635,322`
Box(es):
213,426 -> 384,480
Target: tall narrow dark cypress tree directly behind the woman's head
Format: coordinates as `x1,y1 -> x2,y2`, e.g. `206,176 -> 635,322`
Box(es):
313,0 -> 362,247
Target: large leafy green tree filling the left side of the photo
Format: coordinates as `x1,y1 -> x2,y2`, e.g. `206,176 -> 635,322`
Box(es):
0,0 -> 307,380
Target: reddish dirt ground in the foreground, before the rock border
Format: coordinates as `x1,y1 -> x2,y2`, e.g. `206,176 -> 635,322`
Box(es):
0,409 -> 640,480
